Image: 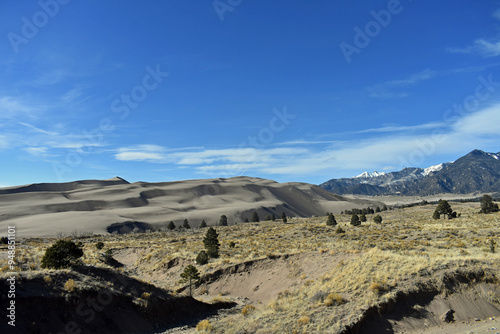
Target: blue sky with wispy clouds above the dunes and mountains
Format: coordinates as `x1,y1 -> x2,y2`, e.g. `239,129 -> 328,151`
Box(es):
0,0 -> 500,186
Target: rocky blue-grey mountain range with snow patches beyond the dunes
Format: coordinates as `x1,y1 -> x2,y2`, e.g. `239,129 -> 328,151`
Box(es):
320,150 -> 500,196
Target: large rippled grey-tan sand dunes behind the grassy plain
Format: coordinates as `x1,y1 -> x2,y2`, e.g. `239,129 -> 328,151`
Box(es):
0,177 -> 381,236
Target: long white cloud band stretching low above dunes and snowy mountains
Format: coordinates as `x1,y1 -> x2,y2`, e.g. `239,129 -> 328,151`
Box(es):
115,104 -> 500,176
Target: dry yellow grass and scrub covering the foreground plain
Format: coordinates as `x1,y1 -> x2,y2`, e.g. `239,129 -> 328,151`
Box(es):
0,203 -> 500,333
